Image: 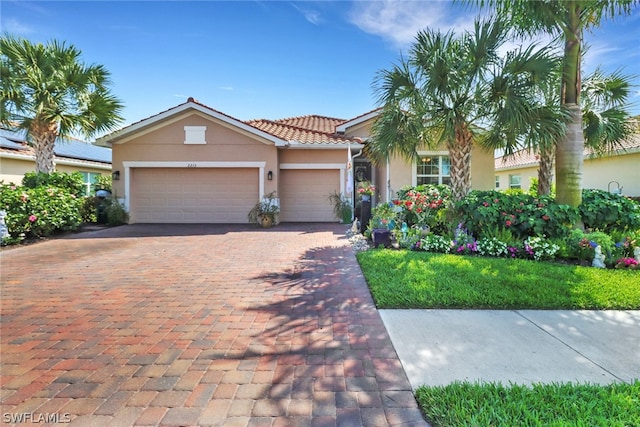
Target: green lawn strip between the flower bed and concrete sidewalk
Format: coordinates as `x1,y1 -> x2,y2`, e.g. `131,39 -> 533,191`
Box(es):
357,249 -> 640,310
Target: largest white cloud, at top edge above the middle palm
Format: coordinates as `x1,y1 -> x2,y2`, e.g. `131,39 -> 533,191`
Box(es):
348,0 -> 476,47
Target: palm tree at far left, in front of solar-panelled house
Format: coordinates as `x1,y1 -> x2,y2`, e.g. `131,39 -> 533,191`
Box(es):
0,35 -> 122,173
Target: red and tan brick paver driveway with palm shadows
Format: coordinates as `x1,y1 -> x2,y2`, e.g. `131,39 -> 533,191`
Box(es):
0,225 -> 426,426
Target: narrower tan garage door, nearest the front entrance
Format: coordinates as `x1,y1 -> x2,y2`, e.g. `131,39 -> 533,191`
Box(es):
280,169 -> 340,222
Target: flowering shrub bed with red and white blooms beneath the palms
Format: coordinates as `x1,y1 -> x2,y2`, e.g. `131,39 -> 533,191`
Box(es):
369,185 -> 640,268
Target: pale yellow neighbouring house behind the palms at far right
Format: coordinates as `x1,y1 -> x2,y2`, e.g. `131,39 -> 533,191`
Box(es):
495,134 -> 640,197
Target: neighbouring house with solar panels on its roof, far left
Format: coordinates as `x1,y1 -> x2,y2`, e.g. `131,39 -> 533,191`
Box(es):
0,129 -> 111,194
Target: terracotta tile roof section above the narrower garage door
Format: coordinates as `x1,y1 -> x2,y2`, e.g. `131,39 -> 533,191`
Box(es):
245,116 -> 362,144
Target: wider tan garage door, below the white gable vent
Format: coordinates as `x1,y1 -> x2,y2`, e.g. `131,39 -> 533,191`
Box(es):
131,168 -> 259,224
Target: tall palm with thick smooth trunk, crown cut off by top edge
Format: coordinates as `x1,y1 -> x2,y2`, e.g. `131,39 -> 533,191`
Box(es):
466,0 -> 637,206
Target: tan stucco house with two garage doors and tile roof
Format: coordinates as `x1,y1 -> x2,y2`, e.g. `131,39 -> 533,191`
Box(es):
97,98 -> 494,223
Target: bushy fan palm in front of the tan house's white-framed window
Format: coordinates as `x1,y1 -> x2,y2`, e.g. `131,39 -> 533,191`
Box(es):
366,21 -> 562,200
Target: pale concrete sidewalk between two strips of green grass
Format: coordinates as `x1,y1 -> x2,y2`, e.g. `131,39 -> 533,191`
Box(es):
380,310 -> 640,390
